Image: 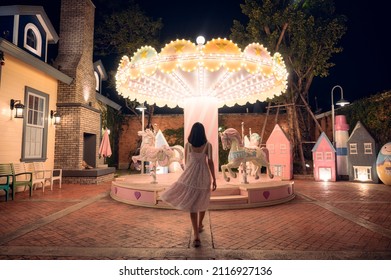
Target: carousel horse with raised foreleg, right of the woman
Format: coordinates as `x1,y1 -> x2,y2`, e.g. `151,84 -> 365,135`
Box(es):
220,128 -> 274,184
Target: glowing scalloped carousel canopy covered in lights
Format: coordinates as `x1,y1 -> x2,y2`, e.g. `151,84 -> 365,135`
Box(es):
116,38 -> 288,108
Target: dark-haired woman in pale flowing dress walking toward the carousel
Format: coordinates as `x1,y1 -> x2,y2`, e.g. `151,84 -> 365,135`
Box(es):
160,122 -> 217,247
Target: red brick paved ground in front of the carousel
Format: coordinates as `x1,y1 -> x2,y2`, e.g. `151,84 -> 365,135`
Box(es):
0,177 -> 391,260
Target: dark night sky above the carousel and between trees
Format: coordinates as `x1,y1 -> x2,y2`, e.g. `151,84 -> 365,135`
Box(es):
0,0 -> 391,111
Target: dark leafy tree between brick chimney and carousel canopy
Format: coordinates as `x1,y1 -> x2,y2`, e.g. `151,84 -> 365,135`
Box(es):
94,0 -> 163,166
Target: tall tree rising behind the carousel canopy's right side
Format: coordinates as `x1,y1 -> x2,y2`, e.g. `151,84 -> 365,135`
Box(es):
231,0 -> 346,173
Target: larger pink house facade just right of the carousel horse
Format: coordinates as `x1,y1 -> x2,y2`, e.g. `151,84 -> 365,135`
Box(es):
266,124 -> 293,180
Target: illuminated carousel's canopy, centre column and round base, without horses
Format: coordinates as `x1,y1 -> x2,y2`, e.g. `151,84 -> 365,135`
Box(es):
111,36 -> 295,209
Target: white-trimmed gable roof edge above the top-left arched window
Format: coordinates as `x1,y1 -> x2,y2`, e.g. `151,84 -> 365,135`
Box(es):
0,5 -> 59,44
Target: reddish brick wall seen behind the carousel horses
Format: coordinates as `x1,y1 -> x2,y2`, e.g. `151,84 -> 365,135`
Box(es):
118,113 -> 287,169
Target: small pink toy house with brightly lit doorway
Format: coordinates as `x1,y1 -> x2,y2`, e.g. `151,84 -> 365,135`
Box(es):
312,132 -> 336,182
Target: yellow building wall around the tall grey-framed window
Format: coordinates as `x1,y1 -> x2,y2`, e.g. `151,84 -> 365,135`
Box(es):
0,54 -> 58,169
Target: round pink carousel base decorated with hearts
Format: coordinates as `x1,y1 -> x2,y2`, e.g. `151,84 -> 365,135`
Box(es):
110,173 -> 295,210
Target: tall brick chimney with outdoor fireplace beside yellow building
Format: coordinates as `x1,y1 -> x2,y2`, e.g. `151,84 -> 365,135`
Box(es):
54,0 -> 101,170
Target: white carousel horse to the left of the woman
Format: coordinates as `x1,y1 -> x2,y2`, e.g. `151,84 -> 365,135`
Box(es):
132,129 -> 184,183
